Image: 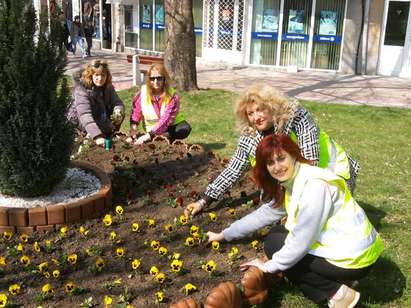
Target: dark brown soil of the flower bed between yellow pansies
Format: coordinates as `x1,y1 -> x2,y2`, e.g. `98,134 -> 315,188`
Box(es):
0,136 -> 270,307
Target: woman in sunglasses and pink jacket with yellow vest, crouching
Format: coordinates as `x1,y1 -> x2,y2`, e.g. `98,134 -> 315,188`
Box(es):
128,63 -> 191,144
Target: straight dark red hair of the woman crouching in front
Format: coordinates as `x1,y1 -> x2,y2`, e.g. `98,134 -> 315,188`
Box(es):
253,134 -> 311,207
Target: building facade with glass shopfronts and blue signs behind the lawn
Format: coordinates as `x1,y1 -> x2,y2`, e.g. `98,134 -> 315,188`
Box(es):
35,0 -> 411,77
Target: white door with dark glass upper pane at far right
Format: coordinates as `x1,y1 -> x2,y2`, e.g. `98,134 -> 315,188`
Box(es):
378,1 -> 411,75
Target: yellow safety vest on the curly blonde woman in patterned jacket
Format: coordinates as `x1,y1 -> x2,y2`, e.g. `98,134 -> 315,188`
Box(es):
248,131 -> 350,180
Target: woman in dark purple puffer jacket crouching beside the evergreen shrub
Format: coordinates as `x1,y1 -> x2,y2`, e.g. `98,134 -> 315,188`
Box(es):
67,60 -> 124,146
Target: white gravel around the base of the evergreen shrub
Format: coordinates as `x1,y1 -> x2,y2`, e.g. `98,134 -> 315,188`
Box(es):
0,168 -> 101,208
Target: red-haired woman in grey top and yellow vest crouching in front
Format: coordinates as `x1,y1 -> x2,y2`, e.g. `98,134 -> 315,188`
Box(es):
207,134 -> 384,307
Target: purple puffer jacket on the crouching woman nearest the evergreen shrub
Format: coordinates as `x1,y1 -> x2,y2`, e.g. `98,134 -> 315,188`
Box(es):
67,73 -> 124,139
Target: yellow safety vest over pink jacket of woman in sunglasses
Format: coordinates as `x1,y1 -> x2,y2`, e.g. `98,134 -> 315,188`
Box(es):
140,85 -> 184,132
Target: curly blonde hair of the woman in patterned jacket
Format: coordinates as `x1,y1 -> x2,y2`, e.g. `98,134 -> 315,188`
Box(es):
235,84 -> 298,134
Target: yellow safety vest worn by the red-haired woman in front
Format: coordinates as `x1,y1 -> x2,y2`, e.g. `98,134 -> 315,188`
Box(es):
284,164 -> 384,268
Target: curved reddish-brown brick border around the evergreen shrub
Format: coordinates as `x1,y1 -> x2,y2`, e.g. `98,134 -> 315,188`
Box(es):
0,161 -> 112,234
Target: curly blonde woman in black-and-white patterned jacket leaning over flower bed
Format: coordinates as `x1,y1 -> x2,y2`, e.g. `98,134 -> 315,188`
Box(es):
185,84 -> 360,216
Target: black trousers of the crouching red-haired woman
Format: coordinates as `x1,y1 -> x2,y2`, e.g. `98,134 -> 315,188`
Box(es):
264,225 -> 372,303
